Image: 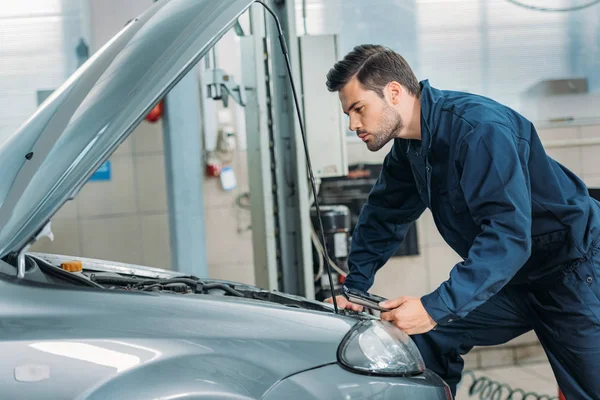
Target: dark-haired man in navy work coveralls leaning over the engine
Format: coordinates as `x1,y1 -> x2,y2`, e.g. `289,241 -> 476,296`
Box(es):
327,45 -> 600,399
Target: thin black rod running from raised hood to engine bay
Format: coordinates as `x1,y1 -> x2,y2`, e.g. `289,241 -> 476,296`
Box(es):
256,0 -> 339,314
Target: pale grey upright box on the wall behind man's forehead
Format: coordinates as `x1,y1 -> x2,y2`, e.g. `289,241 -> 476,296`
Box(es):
298,35 -> 348,178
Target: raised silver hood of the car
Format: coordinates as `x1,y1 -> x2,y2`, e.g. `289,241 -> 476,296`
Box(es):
0,0 -> 253,257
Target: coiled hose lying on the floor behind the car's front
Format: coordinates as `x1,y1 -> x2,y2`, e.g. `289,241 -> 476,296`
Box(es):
461,371 -> 558,400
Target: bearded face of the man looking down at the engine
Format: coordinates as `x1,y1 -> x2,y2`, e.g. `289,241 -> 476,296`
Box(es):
339,78 -> 404,151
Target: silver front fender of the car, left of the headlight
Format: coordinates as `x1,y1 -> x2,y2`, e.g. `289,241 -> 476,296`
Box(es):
0,260 -> 356,399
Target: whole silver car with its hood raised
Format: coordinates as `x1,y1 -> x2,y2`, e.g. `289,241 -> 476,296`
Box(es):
0,0 -> 451,400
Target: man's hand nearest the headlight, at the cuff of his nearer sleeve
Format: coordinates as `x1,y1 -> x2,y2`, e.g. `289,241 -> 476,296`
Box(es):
379,296 -> 437,335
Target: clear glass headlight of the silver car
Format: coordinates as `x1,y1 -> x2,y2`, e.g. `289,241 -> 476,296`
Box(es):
338,320 -> 425,376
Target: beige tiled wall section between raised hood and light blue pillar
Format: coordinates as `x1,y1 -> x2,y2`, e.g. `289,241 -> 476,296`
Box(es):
32,123 -> 171,268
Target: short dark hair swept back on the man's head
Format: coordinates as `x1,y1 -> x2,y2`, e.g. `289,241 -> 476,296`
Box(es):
327,44 -> 421,98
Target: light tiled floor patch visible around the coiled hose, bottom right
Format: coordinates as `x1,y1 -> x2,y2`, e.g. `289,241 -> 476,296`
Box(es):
456,361 -> 558,400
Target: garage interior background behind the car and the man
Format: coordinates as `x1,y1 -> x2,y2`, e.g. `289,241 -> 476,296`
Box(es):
0,0 -> 600,398
